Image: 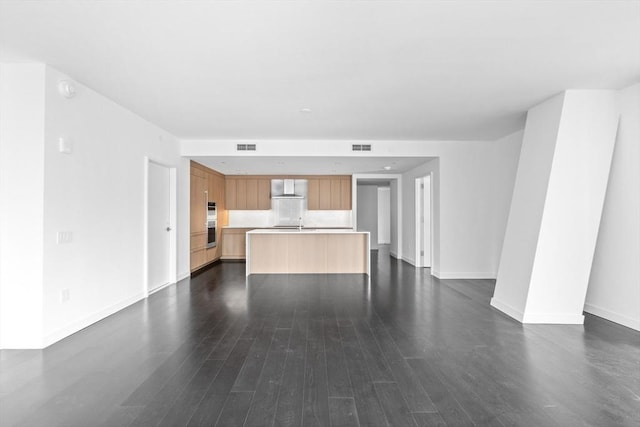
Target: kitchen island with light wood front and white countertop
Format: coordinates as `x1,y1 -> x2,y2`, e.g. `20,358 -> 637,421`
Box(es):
246,228 -> 371,276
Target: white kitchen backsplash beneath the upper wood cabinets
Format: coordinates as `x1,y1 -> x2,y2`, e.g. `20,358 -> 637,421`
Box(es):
229,209 -> 353,227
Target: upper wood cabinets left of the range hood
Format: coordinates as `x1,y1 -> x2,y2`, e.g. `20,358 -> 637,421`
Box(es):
225,176 -> 271,210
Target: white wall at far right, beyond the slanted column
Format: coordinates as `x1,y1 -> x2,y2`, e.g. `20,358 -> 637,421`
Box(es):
584,84 -> 640,330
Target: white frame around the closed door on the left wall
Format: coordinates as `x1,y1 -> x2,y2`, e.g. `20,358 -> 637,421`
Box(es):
142,156 -> 178,298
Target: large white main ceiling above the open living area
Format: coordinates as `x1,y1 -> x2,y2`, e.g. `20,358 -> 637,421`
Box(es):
0,0 -> 640,144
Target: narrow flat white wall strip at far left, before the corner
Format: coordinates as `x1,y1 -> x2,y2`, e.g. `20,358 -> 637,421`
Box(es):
0,64 -> 45,348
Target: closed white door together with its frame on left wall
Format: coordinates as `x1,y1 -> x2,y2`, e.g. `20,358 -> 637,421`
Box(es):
144,158 -> 177,296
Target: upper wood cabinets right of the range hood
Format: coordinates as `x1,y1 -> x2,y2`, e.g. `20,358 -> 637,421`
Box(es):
307,176 -> 351,211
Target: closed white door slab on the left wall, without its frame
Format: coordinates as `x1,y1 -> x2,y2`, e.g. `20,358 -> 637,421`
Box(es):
147,162 -> 171,292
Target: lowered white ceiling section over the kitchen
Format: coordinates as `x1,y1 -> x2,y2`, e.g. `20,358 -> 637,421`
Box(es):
192,156 -> 432,175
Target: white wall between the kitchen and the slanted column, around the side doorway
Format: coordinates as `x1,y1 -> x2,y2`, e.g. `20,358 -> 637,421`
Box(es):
402,132 -> 522,278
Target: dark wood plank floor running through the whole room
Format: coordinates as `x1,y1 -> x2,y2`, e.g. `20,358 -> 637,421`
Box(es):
0,250 -> 640,427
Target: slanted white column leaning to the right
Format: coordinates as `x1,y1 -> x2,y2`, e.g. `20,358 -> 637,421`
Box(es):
491,90 -> 618,324
